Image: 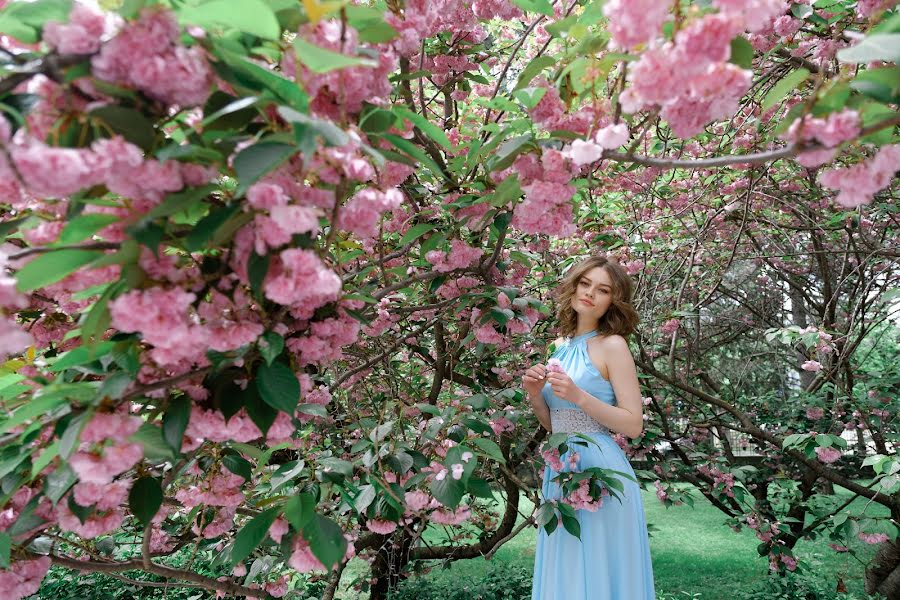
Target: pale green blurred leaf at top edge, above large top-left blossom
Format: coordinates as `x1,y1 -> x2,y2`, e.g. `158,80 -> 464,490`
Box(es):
178,0 -> 281,41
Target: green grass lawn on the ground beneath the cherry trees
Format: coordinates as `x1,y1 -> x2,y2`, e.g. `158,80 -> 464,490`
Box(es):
338,487 -> 888,600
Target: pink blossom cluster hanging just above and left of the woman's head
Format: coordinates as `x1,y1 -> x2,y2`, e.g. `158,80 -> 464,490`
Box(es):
512,150 -> 577,237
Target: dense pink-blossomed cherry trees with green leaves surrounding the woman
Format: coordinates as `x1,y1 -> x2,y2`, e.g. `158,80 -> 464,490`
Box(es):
0,0 -> 900,598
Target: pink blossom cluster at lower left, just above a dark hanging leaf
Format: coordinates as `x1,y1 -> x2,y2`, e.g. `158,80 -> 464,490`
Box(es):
69,413 -> 144,484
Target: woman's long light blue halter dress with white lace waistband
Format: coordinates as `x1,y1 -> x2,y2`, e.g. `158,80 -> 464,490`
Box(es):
531,331 -> 656,600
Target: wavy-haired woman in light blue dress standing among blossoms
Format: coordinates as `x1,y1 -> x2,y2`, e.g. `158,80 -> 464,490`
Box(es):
523,256 -> 656,600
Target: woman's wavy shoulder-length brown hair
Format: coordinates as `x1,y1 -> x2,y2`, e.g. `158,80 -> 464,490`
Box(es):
553,256 -> 640,338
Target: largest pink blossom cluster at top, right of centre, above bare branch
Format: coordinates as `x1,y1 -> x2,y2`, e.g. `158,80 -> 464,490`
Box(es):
619,15 -> 752,137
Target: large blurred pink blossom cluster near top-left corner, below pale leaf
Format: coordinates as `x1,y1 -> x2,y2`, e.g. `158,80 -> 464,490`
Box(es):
91,8 -> 213,107
